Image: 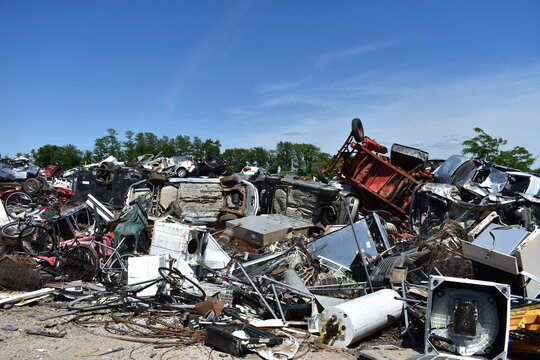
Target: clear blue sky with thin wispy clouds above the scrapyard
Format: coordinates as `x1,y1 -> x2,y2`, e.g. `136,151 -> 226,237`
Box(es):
0,0 -> 540,164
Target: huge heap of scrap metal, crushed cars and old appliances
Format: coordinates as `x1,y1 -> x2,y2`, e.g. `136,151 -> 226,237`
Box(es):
0,119 -> 540,359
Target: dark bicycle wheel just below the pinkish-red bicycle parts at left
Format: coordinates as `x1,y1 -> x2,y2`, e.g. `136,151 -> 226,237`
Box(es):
61,244 -> 99,281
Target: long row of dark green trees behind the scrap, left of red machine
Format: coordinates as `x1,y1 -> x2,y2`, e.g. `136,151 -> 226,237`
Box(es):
18,129 -> 329,176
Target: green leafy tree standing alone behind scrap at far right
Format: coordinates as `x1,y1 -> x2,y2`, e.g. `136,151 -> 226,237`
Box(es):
462,127 -> 536,171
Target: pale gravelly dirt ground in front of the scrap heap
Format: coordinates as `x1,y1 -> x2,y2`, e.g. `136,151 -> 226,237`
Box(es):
0,300 -> 358,360
